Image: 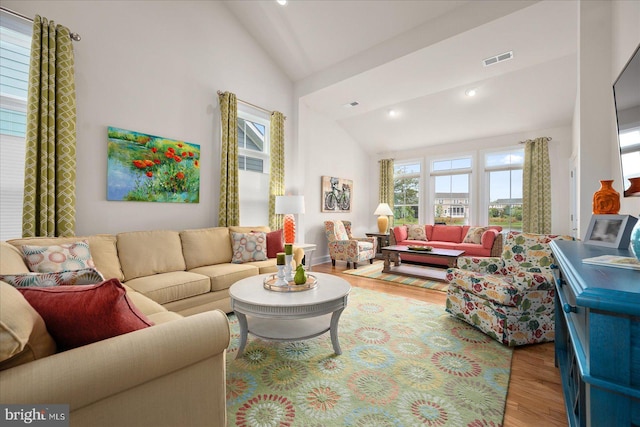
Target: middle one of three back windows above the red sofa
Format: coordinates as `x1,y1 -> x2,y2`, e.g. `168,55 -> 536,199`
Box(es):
431,156 -> 471,225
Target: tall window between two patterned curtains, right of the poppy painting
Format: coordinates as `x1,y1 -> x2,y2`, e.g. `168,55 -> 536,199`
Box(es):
238,108 -> 270,225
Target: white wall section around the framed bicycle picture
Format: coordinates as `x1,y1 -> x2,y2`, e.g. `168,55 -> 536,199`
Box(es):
294,100 -> 378,264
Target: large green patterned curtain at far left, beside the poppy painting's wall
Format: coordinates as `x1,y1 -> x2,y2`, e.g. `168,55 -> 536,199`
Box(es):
22,15 -> 76,237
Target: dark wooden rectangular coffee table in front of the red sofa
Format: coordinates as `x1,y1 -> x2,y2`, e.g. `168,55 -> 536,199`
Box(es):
382,245 -> 464,282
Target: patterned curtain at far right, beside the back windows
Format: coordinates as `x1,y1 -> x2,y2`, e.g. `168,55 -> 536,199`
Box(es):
522,137 -> 551,234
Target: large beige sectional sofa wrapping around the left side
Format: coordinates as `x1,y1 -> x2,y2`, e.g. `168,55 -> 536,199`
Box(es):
0,227 -> 276,426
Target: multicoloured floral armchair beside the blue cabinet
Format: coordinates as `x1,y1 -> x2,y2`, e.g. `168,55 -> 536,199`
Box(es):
446,231 -> 573,346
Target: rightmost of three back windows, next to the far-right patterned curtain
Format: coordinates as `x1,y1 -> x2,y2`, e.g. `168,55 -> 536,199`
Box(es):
485,148 -> 524,231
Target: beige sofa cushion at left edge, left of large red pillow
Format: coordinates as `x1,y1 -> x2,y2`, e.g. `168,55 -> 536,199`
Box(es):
0,281 -> 56,370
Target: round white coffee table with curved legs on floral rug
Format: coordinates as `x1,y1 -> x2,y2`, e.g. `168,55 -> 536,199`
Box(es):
229,273 -> 351,358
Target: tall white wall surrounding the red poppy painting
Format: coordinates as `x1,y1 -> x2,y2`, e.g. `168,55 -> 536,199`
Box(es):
2,0 -> 295,235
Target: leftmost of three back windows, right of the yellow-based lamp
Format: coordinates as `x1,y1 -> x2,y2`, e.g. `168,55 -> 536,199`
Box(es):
393,161 -> 421,224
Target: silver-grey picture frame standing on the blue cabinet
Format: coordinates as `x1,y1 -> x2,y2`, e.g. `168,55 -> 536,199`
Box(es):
584,215 -> 638,249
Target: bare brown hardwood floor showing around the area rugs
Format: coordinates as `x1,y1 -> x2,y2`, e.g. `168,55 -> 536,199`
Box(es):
313,263 -> 567,427
